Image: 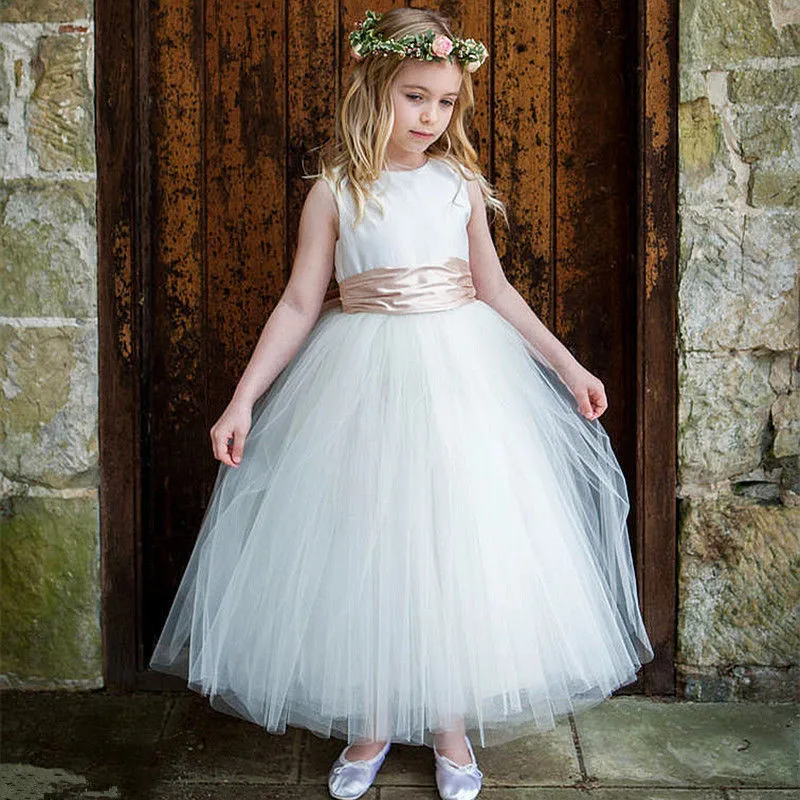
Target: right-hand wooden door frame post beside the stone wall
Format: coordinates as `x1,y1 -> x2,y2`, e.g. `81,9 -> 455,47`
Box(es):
636,0 -> 678,693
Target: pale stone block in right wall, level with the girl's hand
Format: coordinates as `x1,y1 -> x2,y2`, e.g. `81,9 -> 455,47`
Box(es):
678,351 -> 775,484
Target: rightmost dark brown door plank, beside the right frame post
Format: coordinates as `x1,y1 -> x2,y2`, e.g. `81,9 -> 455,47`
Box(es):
553,0 -> 636,472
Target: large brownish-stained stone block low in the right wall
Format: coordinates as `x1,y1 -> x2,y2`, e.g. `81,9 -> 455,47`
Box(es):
677,497 -> 800,667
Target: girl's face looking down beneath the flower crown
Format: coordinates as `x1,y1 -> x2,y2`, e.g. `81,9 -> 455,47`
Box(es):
386,59 -> 462,166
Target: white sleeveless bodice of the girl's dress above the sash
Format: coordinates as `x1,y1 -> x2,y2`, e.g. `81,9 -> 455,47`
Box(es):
329,158 -> 471,283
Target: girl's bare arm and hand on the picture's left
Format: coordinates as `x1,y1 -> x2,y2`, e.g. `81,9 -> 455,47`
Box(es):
211,179 -> 339,467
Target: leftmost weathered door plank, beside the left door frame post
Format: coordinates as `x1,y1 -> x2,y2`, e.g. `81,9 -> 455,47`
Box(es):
140,0 -> 206,668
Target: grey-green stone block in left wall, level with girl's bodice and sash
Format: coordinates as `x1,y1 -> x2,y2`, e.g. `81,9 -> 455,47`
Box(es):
0,180 -> 97,317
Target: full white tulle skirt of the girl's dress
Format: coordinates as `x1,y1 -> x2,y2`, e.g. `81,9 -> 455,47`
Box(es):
150,300 -> 653,747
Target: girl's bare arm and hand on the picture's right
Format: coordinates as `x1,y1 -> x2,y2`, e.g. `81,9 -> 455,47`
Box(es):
467,181 -> 608,419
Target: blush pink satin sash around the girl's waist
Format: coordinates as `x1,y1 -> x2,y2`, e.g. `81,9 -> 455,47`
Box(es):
323,257 -> 475,314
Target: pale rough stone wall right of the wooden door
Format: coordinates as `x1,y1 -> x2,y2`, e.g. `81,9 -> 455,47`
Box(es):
677,0 -> 800,700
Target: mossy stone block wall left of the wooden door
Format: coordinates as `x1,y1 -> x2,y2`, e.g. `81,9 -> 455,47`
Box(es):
0,0 -> 102,688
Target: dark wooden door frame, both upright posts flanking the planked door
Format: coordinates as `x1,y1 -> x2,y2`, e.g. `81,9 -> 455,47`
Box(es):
94,0 -> 678,695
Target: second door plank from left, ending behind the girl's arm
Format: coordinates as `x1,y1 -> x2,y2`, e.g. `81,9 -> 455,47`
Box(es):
204,0 -> 287,424
